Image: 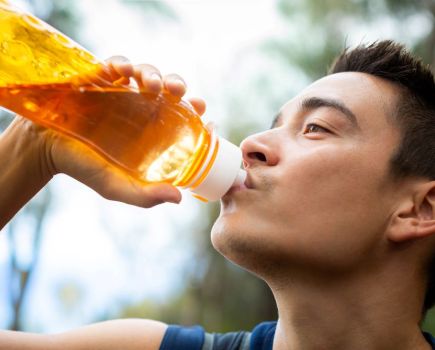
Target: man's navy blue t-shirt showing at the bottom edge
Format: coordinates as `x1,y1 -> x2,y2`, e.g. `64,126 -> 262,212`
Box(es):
160,322 -> 435,350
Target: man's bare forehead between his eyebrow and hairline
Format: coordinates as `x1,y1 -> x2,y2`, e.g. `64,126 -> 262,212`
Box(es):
281,72 -> 399,129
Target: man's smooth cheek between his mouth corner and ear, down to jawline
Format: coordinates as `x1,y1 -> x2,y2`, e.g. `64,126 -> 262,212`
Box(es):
269,148 -> 394,263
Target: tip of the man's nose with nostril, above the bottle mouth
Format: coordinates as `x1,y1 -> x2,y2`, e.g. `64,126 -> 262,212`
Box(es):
240,132 -> 279,169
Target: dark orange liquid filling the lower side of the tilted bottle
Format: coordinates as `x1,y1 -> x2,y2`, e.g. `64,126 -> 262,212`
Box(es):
0,84 -> 210,186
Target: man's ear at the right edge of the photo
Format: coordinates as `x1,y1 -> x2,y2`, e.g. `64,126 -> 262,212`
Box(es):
386,181 -> 435,243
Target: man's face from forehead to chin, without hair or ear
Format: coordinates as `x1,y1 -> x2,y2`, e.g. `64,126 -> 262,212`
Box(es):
212,72 -> 400,274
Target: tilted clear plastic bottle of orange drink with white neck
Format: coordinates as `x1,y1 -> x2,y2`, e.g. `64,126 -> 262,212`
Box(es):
0,0 -> 245,201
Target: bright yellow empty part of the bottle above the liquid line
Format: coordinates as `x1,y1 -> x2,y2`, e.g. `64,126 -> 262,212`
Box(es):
0,0 -> 101,86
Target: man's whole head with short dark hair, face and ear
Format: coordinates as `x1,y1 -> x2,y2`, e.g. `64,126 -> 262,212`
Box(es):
212,41 -> 435,312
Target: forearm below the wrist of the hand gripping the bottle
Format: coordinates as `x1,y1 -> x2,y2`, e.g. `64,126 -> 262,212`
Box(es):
0,118 -> 52,229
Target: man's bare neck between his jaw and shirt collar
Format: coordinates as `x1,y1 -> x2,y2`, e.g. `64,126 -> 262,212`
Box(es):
270,256 -> 430,350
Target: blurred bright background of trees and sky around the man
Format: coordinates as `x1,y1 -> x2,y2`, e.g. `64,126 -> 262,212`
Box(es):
0,0 -> 435,332
